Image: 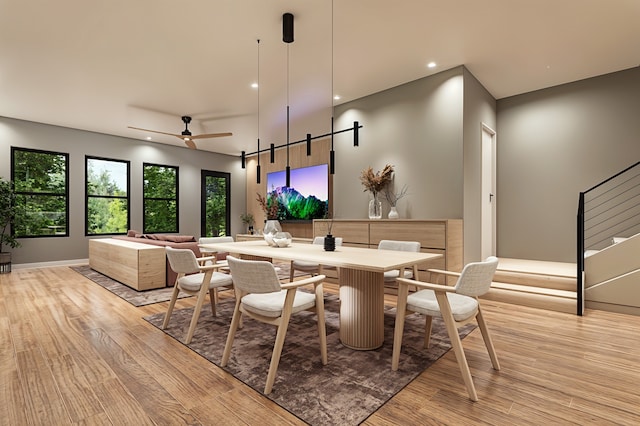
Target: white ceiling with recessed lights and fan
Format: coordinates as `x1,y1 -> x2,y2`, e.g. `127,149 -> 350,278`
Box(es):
0,0 -> 640,155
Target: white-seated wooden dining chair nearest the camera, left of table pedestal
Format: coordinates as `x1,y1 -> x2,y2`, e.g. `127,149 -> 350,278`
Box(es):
220,256 -> 327,395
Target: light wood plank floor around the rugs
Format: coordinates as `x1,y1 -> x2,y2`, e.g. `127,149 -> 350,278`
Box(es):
0,267 -> 640,425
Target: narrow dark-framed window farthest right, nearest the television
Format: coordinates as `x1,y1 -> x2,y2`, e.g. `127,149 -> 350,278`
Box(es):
200,170 -> 231,237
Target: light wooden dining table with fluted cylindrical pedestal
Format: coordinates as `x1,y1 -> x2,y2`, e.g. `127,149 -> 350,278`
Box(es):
200,240 -> 442,350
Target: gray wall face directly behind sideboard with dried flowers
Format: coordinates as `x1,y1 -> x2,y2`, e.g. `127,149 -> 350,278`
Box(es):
333,67 -> 463,219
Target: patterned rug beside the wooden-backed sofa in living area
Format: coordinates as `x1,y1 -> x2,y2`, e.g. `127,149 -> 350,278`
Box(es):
70,263 -> 304,306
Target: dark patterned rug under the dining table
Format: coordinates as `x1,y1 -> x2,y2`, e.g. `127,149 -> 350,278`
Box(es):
144,295 -> 475,425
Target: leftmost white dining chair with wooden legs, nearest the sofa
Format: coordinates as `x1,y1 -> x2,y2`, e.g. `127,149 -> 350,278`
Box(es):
162,247 -> 233,345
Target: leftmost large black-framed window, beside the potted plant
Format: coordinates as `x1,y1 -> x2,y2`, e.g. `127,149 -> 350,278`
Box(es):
11,147 -> 69,238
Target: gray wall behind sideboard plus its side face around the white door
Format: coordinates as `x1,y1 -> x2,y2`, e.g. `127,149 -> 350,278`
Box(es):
333,67 -> 496,262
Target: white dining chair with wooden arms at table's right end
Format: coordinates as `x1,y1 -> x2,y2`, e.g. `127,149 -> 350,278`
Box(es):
391,256 -> 500,401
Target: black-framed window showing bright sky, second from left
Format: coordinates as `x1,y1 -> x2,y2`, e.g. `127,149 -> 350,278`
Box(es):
85,156 -> 129,235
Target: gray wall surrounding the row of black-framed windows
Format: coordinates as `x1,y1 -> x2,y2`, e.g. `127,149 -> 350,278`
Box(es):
0,117 -> 246,264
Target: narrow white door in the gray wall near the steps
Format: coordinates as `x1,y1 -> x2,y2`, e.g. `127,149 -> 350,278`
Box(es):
480,123 -> 496,259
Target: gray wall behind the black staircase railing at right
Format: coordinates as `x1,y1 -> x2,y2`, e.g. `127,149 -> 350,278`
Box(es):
500,68 -> 640,262
